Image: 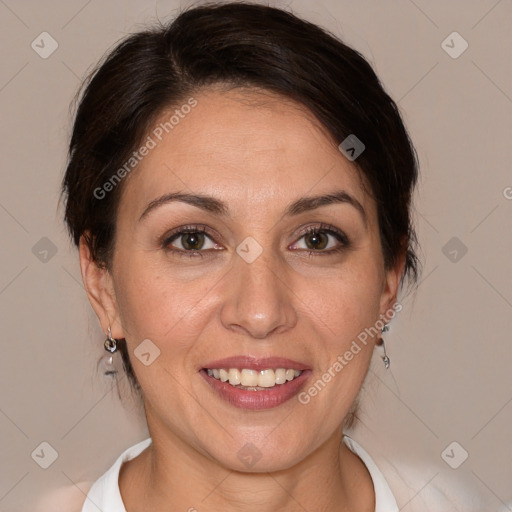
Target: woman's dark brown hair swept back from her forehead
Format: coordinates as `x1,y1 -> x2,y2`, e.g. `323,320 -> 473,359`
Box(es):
62,2 -> 418,404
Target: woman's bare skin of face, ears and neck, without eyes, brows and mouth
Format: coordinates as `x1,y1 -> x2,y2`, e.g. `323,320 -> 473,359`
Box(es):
80,88 -> 403,512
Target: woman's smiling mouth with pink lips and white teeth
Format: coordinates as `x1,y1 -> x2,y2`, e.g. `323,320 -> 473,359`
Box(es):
199,357 -> 311,410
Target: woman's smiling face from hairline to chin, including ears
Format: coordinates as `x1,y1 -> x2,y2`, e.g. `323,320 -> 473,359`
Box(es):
81,90 -> 401,471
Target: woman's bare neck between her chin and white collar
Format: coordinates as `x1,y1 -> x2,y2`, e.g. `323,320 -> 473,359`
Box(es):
119,432 -> 375,512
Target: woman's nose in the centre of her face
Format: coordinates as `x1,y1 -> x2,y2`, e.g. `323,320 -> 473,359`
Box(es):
221,249 -> 297,339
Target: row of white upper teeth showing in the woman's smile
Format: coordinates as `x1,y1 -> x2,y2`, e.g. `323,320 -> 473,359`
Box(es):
206,368 -> 302,391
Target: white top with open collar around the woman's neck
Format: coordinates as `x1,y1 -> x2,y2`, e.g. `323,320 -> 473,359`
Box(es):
82,436 -> 399,512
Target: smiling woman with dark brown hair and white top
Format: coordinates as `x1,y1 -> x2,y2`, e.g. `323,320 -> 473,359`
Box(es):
63,3 -> 417,512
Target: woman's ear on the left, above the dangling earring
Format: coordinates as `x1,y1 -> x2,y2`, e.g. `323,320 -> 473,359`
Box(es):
79,235 -> 125,339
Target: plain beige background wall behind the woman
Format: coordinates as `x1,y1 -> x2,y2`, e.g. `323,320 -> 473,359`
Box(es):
0,0 -> 512,512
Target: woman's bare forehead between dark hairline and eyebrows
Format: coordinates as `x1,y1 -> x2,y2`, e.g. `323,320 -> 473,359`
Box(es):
117,90 -> 369,220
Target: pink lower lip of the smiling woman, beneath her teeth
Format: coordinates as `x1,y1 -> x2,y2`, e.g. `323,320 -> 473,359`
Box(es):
199,370 -> 311,410
